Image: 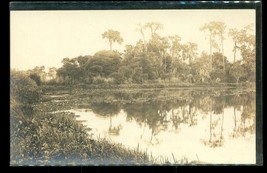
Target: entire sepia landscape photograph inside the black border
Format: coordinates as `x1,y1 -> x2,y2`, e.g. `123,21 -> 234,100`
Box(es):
10,5 -> 257,166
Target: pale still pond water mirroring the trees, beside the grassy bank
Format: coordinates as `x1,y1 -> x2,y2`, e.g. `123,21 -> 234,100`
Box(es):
69,91 -> 256,164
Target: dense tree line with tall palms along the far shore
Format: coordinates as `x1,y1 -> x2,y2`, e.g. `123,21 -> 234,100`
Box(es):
19,21 -> 256,84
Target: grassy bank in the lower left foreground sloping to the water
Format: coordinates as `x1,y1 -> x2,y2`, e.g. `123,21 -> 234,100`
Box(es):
10,100 -> 150,165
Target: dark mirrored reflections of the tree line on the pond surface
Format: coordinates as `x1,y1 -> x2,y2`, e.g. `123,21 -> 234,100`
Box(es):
87,90 -> 256,148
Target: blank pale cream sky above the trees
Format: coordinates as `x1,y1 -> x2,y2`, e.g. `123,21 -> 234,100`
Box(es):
10,9 -> 255,70
